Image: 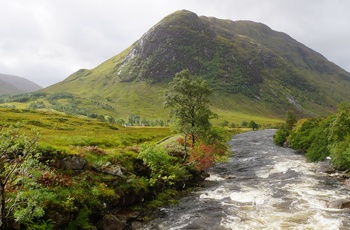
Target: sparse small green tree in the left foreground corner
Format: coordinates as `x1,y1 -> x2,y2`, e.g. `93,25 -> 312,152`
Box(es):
0,125 -> 51,229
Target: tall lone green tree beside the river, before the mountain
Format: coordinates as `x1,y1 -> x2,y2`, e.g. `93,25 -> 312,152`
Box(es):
165,69 -> 217,150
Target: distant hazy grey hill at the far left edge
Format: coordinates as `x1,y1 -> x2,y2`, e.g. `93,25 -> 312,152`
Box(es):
0,74 -> 42,95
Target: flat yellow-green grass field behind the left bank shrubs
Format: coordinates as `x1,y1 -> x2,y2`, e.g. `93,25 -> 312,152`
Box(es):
0,108 -> 170,151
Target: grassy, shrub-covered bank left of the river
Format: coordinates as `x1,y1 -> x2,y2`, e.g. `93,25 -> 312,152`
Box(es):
0,71 -> 243,229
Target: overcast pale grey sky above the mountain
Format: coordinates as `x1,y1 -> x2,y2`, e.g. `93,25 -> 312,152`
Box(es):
0,0 -> 350,87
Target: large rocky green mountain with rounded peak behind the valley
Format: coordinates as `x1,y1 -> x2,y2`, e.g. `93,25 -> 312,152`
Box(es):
44,10 -> 350,117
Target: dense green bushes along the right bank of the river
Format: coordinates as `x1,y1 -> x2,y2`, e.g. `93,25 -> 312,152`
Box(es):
274,102 -> 350,170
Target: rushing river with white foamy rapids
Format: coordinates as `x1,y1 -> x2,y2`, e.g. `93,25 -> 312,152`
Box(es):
142,130 -> 350,230
